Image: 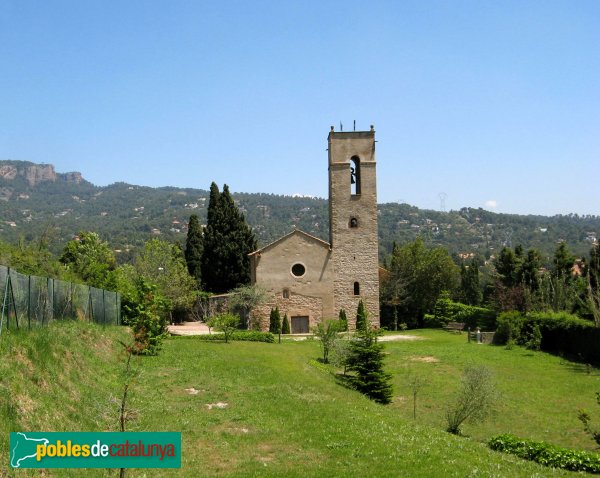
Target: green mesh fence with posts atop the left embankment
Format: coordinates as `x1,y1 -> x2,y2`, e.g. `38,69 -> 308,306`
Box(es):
0,266 -> 121,332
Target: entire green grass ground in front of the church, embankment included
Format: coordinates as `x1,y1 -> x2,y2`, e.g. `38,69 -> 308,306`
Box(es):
0,324 -> 600,478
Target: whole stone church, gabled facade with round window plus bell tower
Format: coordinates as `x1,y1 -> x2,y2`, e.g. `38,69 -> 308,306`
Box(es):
250,126 -> 379,333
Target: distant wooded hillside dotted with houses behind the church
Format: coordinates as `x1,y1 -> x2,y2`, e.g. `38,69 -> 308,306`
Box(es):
0,161 -> 600,262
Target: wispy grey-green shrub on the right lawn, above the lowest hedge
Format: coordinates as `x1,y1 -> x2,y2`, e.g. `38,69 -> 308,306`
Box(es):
446,365 -> 497,435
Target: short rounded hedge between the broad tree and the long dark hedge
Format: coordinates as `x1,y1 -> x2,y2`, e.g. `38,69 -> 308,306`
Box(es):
425,297 -> 496,330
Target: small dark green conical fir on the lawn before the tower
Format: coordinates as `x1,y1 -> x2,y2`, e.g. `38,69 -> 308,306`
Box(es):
347,324 -> 393,404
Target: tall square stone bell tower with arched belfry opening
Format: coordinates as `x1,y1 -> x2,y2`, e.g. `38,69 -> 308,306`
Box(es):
328,126 -> 379,328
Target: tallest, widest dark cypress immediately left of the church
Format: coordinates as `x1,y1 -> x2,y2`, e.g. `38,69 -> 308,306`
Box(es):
201,182 -> 257,293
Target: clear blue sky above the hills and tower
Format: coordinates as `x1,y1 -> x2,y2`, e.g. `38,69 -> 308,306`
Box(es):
0,0 -> 600,214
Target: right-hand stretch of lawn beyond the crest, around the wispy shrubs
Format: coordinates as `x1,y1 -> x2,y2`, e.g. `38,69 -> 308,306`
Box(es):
386,330 -> 600,451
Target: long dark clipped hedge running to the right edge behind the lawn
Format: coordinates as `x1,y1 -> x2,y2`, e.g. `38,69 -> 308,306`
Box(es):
494,311 -> 600,363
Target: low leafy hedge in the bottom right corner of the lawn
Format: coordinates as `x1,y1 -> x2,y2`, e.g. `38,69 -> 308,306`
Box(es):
488,434 -> 600,474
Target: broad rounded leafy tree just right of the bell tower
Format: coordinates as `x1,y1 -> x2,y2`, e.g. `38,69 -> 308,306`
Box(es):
384,238 -> 460,326
